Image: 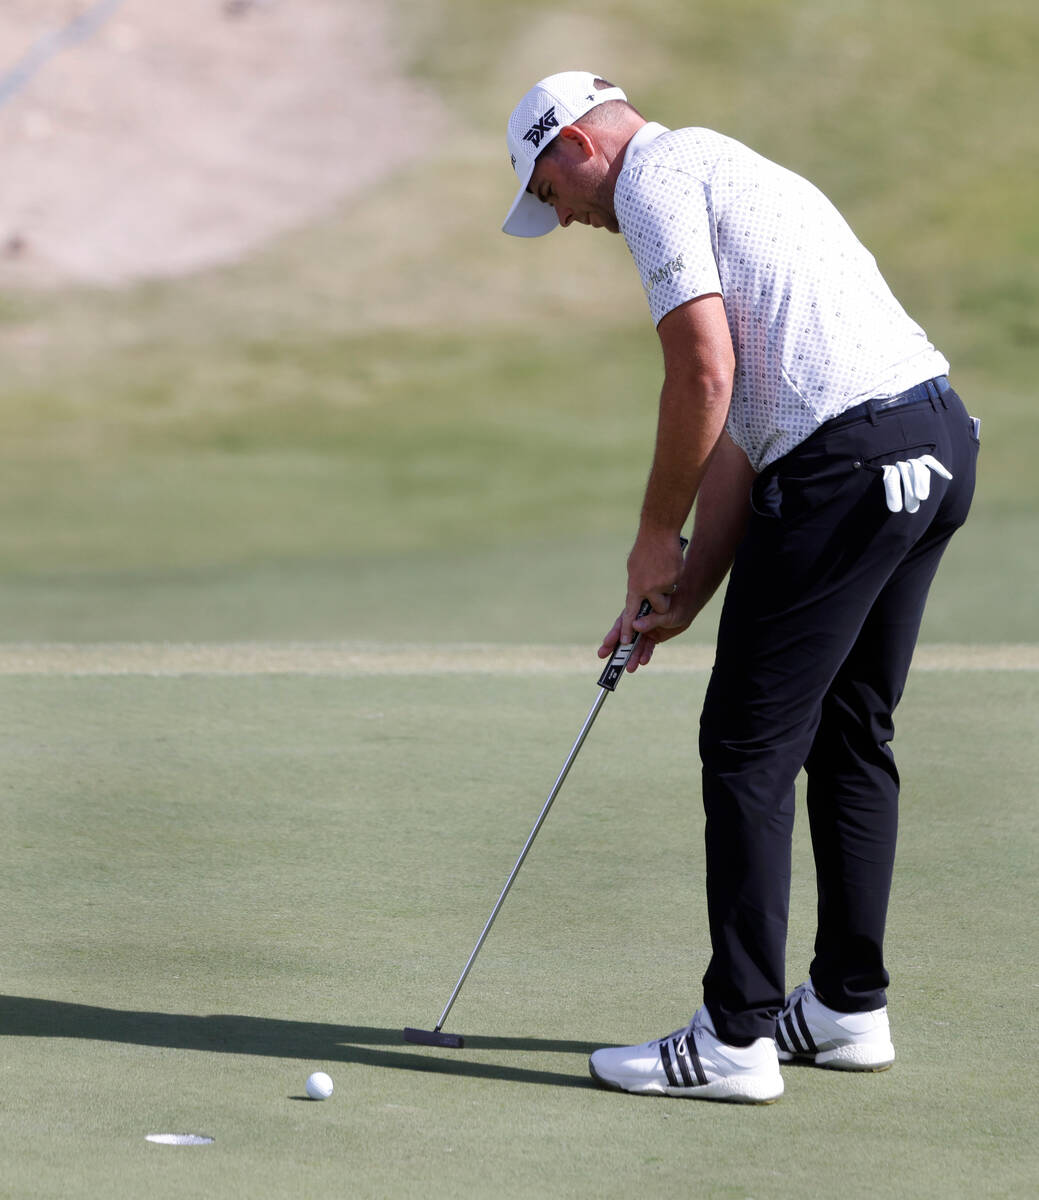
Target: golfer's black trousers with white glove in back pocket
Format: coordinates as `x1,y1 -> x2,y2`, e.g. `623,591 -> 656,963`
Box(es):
699,385 -> 978,1042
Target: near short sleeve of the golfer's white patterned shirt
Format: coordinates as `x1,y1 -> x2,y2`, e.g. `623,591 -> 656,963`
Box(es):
614,164 -> 721,324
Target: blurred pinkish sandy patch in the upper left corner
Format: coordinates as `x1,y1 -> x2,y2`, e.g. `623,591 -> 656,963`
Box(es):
0,0 -> 442,287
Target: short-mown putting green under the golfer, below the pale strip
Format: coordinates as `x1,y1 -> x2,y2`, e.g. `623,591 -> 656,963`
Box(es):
0,665 -> 1039,1200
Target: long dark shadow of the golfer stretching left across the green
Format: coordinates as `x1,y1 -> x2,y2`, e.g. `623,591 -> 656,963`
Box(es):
0,996 -> 601,1087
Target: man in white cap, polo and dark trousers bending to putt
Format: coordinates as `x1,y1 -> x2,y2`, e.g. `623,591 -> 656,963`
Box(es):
504,71 -> 978,1103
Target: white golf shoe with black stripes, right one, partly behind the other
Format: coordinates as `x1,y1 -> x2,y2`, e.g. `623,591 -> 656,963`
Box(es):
776,983 -> 895,1070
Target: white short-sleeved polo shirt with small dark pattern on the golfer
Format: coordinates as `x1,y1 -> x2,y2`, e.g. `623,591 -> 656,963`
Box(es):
614,124 -> 949,470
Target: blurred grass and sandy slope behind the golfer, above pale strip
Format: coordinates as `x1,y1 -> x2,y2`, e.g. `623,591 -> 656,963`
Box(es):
0,0 -> 1039,644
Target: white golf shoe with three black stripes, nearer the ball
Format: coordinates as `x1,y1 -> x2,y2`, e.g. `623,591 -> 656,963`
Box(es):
588,1008 -> 783,1104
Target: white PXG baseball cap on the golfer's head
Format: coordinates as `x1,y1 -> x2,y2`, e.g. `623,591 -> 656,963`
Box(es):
502,71 -> 627,238
